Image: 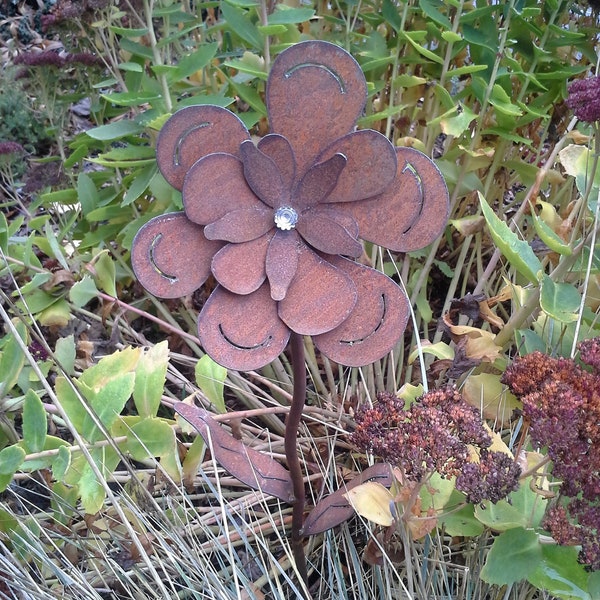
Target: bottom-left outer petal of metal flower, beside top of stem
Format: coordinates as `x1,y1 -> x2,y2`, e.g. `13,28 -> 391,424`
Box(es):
198,284 -> 290,371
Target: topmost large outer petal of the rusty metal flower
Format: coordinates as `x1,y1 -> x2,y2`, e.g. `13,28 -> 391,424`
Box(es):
266,41 -> 367,174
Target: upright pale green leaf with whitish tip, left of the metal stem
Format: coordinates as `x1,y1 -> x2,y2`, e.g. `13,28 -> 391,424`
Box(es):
133,341 -> 169,417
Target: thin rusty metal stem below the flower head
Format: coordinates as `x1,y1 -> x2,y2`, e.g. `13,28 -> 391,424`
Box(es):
284,332 -> 310,599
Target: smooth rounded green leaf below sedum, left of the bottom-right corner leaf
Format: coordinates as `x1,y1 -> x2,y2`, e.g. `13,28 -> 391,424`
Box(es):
481,527 -> 542,585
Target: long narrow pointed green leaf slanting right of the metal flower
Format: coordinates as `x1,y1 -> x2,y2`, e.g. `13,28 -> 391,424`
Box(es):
478,192 -> 542,283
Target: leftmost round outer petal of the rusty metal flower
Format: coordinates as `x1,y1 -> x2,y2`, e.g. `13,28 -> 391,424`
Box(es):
131,213 -> 223,298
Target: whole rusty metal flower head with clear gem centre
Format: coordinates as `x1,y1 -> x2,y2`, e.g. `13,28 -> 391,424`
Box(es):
132,41 -> 448,370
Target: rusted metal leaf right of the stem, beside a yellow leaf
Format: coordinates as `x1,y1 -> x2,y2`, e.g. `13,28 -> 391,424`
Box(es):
302,463 -> 394,535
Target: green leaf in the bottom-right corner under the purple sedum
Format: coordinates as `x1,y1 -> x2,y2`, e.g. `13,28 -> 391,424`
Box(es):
527,544 -> 600,600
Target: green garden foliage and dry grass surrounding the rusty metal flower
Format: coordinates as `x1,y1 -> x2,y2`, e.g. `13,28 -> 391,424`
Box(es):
0,0 -> 600,599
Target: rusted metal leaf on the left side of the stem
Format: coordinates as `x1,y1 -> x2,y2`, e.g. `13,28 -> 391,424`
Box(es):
173,402 -> 294,502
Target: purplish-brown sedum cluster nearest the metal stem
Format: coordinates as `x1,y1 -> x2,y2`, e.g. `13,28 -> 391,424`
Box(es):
352,387 -> 521,504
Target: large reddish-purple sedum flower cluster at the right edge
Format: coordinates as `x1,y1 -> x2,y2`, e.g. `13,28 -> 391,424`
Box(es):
503,338 -> 600,570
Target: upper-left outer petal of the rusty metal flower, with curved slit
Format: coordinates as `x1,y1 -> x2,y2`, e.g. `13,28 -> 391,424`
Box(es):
156,105 -> 250,190
